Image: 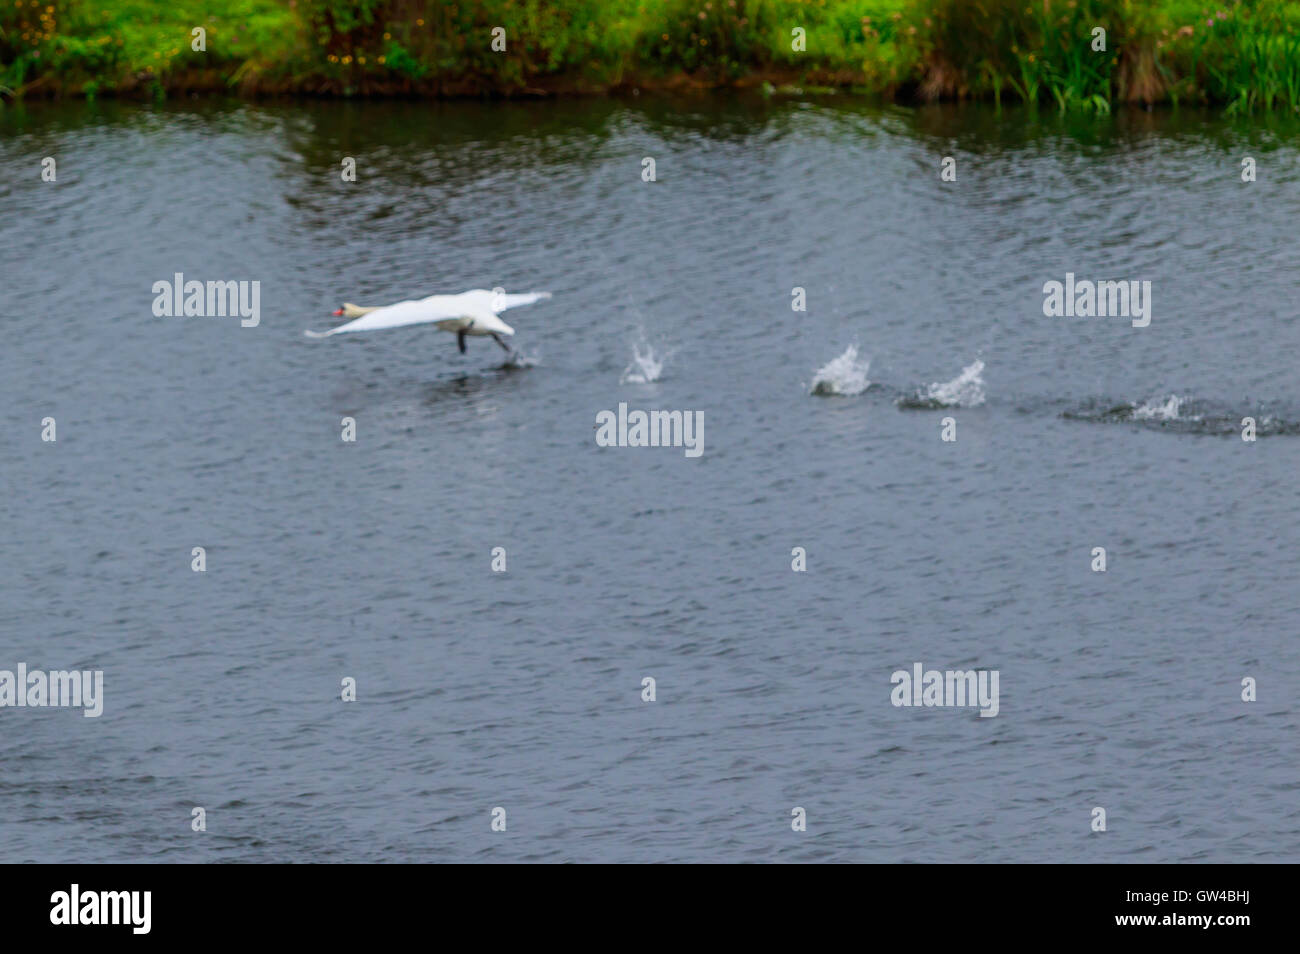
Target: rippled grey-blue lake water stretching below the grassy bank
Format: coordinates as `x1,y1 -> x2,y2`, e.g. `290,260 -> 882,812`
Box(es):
0,96 -> 1300,862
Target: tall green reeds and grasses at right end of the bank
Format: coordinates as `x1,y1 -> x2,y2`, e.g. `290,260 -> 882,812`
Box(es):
909,0 -> 1300,110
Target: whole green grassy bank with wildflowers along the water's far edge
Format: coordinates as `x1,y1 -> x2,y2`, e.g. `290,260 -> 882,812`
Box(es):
0,0 -> 1300,110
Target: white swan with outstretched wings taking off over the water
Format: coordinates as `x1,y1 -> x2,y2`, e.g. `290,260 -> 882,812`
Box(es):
304,289 -> 551,354
